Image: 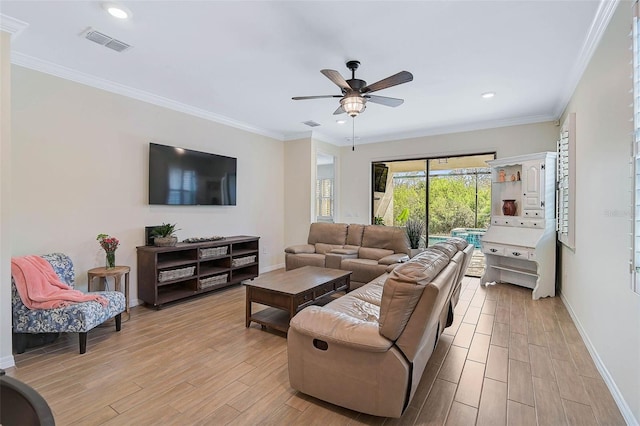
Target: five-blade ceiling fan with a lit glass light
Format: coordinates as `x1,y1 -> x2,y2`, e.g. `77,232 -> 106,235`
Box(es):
292,61 -> 413,117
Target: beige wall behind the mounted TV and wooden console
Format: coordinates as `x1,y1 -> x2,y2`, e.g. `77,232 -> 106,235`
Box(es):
9,66 -> 285,306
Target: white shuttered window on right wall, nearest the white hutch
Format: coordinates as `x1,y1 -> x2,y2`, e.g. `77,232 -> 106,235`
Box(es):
556,113 -> 576,249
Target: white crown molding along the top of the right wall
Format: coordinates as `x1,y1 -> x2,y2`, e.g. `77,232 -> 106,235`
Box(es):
554,0 -> 620,120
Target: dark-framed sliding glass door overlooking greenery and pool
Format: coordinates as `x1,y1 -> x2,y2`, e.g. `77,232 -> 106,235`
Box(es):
371,153 -> 495,276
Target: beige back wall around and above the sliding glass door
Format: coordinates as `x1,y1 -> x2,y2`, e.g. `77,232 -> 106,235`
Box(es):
336,122 -> 559,224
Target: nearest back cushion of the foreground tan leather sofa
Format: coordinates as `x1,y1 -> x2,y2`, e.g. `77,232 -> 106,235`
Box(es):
380,249 -> 449,341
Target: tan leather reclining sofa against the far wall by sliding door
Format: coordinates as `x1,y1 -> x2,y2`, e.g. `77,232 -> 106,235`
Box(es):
285,223 -> 410,289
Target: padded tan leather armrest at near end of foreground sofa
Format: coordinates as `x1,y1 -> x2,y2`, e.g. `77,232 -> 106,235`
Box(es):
290,306 -> 393,352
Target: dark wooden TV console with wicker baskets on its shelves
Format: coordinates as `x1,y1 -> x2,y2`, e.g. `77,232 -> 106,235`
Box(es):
137,235 -> 260,308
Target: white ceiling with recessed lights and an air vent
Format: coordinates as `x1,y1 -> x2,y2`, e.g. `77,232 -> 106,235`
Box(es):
0,0 -> 615,145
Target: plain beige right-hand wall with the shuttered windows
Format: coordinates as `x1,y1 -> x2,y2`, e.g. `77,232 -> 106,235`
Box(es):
560,2 -> 640,421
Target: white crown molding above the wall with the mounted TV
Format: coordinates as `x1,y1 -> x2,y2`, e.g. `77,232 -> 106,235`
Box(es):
11,52 -> 284,141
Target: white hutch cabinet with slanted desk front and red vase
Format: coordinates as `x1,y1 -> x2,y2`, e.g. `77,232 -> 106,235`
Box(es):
481,152 -> 556,299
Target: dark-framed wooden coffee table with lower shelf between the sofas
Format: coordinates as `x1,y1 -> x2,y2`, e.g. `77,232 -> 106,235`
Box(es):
245,266 -> 351,333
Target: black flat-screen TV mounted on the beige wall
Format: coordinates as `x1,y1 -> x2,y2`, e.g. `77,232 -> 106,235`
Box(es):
149,143 -> 237,206
